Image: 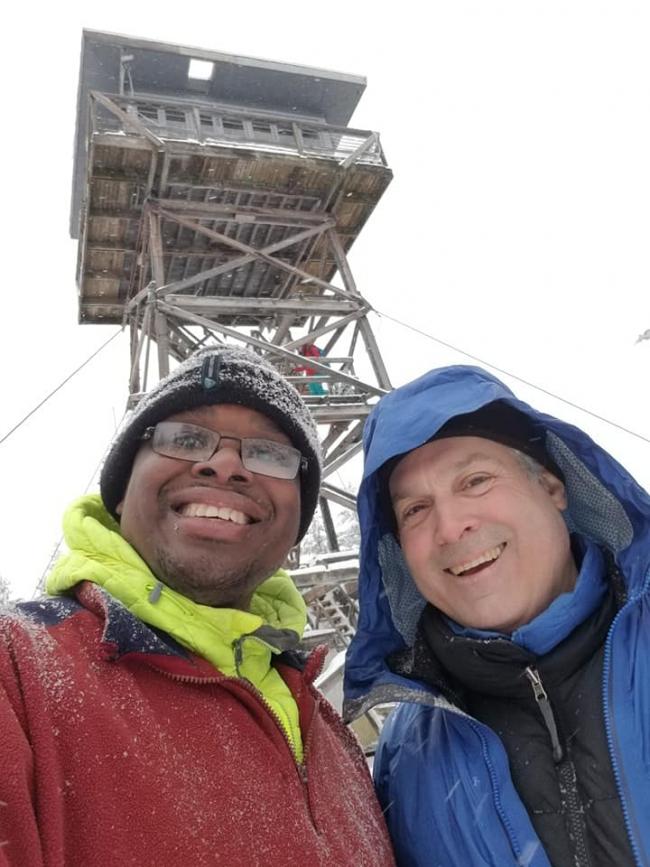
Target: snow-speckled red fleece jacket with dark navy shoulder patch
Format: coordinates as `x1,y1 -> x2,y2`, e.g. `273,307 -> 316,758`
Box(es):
0,584 -> 394,867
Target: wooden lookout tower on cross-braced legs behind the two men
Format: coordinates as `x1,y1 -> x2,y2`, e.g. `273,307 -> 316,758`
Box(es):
70,31 -> 392,732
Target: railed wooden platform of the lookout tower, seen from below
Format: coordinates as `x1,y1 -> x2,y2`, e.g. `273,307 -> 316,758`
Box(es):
78,93 -> 392,327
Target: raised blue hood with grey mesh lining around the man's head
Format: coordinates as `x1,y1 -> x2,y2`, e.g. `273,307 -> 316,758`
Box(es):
344,365 -> 650,719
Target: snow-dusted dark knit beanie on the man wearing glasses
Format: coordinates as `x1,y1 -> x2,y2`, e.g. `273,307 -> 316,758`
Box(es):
99,346 -> 321,543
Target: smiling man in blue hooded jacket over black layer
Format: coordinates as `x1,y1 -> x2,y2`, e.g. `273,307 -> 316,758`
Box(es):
346,367 -> 650,867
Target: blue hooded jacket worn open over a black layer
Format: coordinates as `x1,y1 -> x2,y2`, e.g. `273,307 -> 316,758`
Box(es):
344,366 -> 650,867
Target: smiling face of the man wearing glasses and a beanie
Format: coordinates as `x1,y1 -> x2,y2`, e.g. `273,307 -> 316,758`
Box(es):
114,404 -> 302,611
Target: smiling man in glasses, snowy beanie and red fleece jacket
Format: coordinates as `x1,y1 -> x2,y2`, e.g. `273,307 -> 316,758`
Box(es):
0,347 -> 393,867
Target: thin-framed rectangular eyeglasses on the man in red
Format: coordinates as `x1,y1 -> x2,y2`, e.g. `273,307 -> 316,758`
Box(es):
142,421 -> 307,479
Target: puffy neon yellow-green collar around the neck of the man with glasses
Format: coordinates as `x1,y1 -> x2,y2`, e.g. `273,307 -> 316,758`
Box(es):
47,495 -> 306,682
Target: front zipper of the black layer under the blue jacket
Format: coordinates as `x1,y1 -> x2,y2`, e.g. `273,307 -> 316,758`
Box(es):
524,666 -> 590,867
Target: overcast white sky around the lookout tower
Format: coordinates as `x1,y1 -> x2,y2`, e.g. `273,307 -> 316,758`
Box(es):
0,0 -> 650,597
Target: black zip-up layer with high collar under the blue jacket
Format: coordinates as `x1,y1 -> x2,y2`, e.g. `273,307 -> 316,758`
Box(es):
412,590 -> 635,867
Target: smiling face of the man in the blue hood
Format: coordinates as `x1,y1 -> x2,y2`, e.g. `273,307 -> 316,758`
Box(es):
389,430 -> 577,632
